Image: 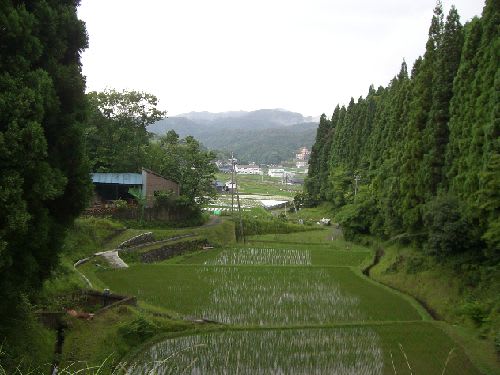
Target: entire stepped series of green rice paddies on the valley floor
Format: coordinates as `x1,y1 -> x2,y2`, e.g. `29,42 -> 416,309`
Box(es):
91,230 -> 479,375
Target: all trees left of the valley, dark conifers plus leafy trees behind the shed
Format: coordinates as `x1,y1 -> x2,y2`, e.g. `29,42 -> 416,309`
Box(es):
0,0 -> 216,374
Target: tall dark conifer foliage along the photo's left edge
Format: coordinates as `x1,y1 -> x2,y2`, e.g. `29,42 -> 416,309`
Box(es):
0,0 -> 90,366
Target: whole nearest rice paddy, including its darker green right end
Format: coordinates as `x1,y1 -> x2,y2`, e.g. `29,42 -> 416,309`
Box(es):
127,323 -> 479,375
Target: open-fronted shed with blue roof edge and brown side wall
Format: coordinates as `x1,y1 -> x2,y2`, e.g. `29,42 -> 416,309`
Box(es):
91,168 -> 180,207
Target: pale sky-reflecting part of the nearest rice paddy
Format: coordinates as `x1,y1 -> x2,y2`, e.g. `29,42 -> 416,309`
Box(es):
128,328 -> 383,375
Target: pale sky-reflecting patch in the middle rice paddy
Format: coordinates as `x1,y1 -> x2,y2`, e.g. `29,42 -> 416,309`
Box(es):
198,267 -> 364,326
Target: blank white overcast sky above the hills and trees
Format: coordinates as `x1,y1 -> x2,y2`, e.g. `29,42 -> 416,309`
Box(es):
78,0 -> 484,116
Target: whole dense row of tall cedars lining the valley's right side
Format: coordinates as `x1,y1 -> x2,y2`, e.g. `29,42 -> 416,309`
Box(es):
306,0 -> 500,262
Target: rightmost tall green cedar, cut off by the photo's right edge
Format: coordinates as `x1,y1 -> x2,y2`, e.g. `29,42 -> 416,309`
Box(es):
446,0 -> 500,260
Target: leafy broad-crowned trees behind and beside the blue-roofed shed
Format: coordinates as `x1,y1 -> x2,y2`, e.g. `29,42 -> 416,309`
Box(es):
85,90 -> 217,207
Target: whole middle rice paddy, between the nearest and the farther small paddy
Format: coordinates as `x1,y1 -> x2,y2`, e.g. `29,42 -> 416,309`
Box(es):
98,265 -> 421,325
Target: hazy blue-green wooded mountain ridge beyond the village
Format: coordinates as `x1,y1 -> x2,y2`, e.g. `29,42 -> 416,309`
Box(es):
148,109 -> 319,164
